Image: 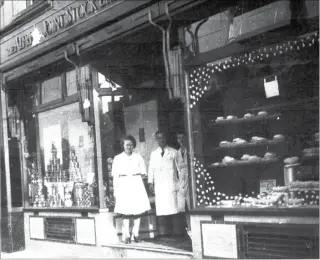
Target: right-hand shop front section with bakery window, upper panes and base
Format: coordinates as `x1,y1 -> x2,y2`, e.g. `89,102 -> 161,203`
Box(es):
180,1 -> 319,258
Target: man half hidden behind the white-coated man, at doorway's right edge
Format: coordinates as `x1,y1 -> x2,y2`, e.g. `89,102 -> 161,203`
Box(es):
176,132 -> 191,238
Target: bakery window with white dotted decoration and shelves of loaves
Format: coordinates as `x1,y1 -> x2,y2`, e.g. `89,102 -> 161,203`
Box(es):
188,33 -> 319,207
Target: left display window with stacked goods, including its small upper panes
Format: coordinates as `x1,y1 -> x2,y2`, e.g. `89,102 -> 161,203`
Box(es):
24,66 -> 99,208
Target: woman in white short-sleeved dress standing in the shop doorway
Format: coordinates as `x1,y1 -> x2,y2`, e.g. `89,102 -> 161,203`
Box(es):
112,135 -> 150,244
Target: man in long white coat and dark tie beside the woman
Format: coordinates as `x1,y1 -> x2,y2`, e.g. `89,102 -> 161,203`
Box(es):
148,131 -> 178,236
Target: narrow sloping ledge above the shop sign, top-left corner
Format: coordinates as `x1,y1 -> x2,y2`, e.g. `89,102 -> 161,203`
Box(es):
0,0 -> 52,36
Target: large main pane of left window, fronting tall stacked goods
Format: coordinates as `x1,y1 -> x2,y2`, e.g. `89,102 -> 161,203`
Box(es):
30,103 -> 98,207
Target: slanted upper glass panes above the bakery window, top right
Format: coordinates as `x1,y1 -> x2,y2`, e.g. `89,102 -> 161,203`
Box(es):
184,0 -> 291,53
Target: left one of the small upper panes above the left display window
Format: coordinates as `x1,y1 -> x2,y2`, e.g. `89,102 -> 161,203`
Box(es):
41,77 -> 61,104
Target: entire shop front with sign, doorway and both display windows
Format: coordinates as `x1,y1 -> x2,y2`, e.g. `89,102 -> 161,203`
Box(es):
0,0 -> 319,258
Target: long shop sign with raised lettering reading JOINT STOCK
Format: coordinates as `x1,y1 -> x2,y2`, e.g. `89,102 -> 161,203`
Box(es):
1,0 -> 123,59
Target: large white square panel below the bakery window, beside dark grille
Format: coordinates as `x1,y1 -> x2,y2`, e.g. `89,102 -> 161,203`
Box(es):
201,223 -> 238,259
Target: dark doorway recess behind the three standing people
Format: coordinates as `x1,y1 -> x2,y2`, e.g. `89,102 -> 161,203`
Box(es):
86,28 -> 191,250
